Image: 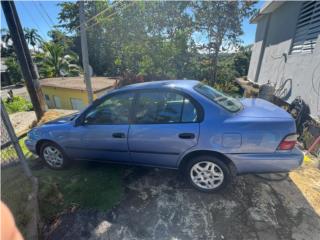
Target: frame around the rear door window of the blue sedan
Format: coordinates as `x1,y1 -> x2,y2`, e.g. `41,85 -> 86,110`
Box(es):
131,88 -> 204,125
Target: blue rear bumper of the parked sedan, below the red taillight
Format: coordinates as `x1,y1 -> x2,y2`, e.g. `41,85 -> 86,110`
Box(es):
227,148 -> 304,174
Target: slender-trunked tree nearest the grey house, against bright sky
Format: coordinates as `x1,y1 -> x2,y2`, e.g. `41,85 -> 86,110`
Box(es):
194,1 -> 255,84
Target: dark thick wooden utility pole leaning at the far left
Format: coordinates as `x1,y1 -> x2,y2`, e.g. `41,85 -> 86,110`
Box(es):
1,1 -> 47,120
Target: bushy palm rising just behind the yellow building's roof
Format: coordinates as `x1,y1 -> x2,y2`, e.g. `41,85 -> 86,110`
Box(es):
35,42 -> 80,77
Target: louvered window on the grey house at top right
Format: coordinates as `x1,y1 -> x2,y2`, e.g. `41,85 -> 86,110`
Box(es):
290,1 -> 320,54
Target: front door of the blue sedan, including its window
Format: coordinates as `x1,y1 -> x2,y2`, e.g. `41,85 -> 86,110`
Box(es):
68,93 -> 133,162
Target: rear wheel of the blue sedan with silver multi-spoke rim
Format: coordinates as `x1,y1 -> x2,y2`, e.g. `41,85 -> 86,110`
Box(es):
185,155 -> 232,193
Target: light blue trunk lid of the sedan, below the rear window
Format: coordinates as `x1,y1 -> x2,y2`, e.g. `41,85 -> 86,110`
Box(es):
239,98 -> 293,120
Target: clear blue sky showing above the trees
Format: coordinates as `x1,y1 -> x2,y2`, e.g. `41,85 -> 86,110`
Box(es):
1,1 -> 264,45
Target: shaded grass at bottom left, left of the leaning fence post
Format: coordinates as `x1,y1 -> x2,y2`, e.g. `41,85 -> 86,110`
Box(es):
1,165 -> 32,236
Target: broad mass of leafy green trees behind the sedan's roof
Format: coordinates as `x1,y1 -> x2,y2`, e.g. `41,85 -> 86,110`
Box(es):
59,0 -> 253,86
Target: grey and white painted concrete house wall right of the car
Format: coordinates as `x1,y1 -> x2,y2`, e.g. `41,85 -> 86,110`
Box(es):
248,2 -> 320,117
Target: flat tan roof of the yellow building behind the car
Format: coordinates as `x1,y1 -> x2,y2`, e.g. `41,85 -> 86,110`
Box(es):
40,76 -> 117,92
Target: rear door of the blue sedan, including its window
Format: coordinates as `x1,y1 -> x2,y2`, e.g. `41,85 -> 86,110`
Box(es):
129,90 -> 199,167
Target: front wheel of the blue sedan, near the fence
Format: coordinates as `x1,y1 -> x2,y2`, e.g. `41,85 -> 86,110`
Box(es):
40,142 -> 70,170
